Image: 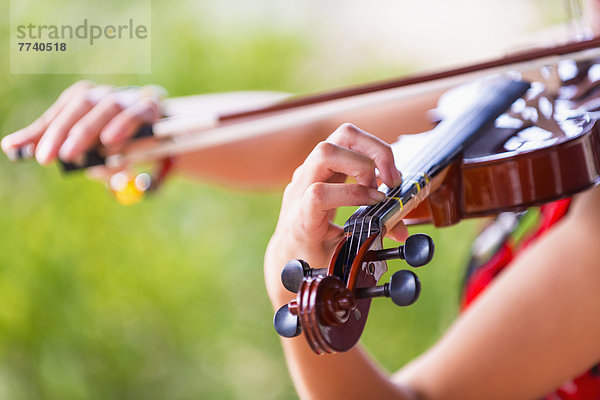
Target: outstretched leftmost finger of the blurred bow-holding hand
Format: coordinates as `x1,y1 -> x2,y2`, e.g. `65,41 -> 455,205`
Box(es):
1,81 -> 93,152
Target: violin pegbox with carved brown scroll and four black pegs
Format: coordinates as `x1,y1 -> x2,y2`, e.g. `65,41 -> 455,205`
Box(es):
273,233 -> 434,354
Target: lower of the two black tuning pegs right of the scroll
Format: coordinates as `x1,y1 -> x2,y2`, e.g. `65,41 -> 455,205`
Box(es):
356,269 -> 421,306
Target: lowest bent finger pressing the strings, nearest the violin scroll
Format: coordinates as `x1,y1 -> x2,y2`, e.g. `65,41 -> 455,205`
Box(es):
300,182 -> 386,232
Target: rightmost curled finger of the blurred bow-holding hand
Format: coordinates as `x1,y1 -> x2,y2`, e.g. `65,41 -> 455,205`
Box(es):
100,98 -> 160,146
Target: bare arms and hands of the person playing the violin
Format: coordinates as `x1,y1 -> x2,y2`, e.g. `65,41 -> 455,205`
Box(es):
2,1 -> 600,399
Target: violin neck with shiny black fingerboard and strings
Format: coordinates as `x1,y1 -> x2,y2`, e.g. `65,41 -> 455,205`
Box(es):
346,78 -> 529,233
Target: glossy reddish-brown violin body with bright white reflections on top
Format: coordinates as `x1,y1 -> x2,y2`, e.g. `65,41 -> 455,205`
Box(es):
400,55 -> 600,226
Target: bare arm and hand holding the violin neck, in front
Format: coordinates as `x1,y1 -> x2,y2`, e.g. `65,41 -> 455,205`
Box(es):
265,122 -> 600,399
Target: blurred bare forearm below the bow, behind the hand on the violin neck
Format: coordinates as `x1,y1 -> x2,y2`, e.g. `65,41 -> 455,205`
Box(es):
177,93 -> 439,188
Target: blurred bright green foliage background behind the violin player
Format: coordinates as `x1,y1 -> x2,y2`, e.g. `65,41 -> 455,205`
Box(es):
0,0 -> 564,399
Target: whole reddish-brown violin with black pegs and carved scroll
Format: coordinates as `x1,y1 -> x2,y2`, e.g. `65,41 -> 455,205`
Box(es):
273,52 -> 600,354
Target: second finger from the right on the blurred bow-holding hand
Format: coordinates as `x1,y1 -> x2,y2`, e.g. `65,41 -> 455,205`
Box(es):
58,95 -> 123,161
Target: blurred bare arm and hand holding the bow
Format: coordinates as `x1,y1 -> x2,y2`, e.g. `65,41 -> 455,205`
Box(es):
2,82 -> 438,188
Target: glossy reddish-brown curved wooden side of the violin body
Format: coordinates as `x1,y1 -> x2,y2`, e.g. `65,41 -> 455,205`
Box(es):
404,120 -> 600,227
